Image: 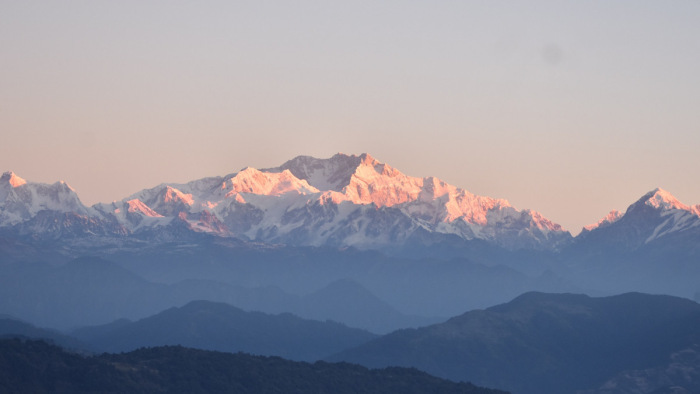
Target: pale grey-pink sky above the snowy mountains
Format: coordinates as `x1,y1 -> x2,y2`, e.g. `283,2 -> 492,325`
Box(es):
0,0 -> 700,234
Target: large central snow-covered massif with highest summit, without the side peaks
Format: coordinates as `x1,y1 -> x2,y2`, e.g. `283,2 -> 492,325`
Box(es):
95,154 -> 570,249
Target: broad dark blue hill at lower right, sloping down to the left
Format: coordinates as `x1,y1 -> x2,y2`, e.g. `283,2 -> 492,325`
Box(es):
329,293 -> 700,394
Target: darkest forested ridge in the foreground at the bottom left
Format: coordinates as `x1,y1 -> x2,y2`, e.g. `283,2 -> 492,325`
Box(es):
0,339 -> 506,394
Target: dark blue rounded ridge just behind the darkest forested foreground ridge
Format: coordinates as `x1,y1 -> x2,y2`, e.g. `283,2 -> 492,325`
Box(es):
72,301 -> 376,361
